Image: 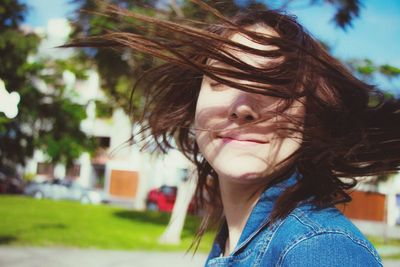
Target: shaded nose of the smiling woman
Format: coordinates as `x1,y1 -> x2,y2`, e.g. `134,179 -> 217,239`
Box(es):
228,92 -> 260,124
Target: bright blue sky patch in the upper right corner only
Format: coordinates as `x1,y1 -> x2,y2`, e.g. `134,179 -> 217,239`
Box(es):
286,0 -> 400,66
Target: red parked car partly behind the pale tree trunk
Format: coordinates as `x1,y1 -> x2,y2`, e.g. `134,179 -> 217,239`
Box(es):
146,185 -> 196,214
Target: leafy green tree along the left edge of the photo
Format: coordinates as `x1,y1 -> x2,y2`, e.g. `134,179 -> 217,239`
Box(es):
0,0 -> 94,175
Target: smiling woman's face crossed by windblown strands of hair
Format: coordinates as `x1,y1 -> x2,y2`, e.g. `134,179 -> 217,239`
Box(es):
195,25 -> 304,183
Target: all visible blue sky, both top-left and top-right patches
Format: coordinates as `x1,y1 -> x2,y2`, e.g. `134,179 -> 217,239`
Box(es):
22,0 -> 400,92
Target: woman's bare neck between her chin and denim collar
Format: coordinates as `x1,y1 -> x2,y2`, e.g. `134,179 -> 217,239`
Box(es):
219,177 -> 265,256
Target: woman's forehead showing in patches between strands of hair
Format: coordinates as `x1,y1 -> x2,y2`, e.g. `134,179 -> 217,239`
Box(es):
208,24 -> 279,67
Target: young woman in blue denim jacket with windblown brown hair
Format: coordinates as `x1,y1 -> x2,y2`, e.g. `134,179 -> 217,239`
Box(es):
70,1 -> 400,266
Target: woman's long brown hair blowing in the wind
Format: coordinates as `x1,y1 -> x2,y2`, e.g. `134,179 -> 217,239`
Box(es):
66,1 -> 400,251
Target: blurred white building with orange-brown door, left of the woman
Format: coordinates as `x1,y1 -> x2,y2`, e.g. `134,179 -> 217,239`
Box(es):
24,21 -> 189,209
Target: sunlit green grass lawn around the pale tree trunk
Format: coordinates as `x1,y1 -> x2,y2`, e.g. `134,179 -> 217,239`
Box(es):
0,195 -> 213,252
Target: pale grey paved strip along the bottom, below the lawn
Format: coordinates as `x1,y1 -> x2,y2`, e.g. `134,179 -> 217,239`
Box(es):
0,246 -> 400,267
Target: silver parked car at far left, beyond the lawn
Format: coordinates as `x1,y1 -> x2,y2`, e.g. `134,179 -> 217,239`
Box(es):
24,179 -> 105,204
